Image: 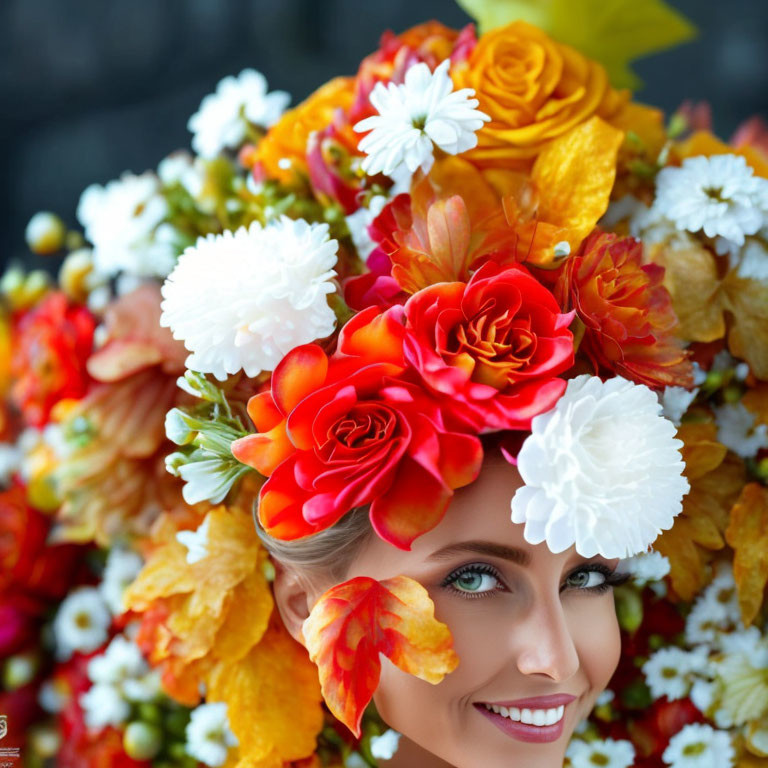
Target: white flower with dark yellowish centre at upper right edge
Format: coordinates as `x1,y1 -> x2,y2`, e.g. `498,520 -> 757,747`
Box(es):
652,155 -> 768,245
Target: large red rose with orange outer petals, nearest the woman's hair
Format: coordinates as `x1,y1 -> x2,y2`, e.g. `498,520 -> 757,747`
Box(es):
232,308 -> 482,549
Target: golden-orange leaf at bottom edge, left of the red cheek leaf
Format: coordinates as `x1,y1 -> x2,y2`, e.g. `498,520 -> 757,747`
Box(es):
206,620 -> 323,766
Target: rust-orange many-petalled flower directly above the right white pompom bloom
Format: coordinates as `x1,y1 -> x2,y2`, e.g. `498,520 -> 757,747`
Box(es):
556,230 -> 693,388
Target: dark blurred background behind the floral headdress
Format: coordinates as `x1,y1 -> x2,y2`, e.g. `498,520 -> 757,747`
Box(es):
0,0 -> 768,264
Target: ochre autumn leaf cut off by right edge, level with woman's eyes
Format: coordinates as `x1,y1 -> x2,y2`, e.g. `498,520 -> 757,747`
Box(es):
725,483 -> 768,626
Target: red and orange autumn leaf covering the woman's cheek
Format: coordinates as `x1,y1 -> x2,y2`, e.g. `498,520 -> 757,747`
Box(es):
303,576 -> 459,738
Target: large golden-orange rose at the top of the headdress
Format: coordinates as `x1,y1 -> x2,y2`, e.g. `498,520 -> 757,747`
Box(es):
452,21 -> 629,169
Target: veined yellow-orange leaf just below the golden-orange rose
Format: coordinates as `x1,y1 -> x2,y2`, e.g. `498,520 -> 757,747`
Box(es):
531,117 -> 624,251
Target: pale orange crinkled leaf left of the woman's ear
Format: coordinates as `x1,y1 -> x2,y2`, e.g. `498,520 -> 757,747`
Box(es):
125,507 -> 273,703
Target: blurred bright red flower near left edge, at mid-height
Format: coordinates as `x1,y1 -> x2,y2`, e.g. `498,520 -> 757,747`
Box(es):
11,293 -> 96,427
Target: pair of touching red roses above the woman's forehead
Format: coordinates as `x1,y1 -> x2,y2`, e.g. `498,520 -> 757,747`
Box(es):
232,263 -> 573,549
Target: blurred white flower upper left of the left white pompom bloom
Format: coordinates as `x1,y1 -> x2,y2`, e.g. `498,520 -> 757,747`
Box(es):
77,172 -> 175,277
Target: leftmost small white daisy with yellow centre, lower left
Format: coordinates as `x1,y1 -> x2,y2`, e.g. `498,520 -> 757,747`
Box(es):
53,587 -> 112,661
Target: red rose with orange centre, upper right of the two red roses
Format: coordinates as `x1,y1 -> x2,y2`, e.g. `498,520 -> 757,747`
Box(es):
400,262 -> 573,431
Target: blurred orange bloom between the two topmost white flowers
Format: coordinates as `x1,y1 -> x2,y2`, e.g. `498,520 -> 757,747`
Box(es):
252,77 -> 357,183
